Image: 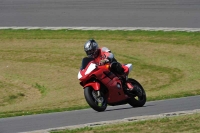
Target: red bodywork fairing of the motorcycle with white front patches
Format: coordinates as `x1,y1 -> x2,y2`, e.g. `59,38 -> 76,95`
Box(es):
78,58 -> 129,104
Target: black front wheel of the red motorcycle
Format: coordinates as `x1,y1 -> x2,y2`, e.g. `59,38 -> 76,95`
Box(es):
84,87 -> 107,112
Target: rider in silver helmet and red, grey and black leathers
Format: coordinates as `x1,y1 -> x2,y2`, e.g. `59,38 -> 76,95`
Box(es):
84,39 -> 127,82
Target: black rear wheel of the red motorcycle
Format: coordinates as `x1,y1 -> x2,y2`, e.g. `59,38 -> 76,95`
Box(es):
128,78 -> 146,107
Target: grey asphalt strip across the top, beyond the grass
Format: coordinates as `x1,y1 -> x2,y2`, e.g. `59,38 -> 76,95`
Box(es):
0,0 -> 200,28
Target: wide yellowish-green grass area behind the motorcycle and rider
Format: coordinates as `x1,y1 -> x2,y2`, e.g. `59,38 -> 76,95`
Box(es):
0,30 -> 200,117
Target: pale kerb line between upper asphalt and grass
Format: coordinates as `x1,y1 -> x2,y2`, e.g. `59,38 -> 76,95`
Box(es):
0,26 -> 200,32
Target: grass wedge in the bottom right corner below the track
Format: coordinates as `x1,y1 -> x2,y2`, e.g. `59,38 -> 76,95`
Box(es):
51,113 -> 200,133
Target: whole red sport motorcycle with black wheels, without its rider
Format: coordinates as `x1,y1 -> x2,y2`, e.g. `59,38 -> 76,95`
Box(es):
78,57 -> 146,112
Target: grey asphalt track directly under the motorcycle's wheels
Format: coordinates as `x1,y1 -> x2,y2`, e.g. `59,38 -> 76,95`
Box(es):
0,96 -> 200,133
